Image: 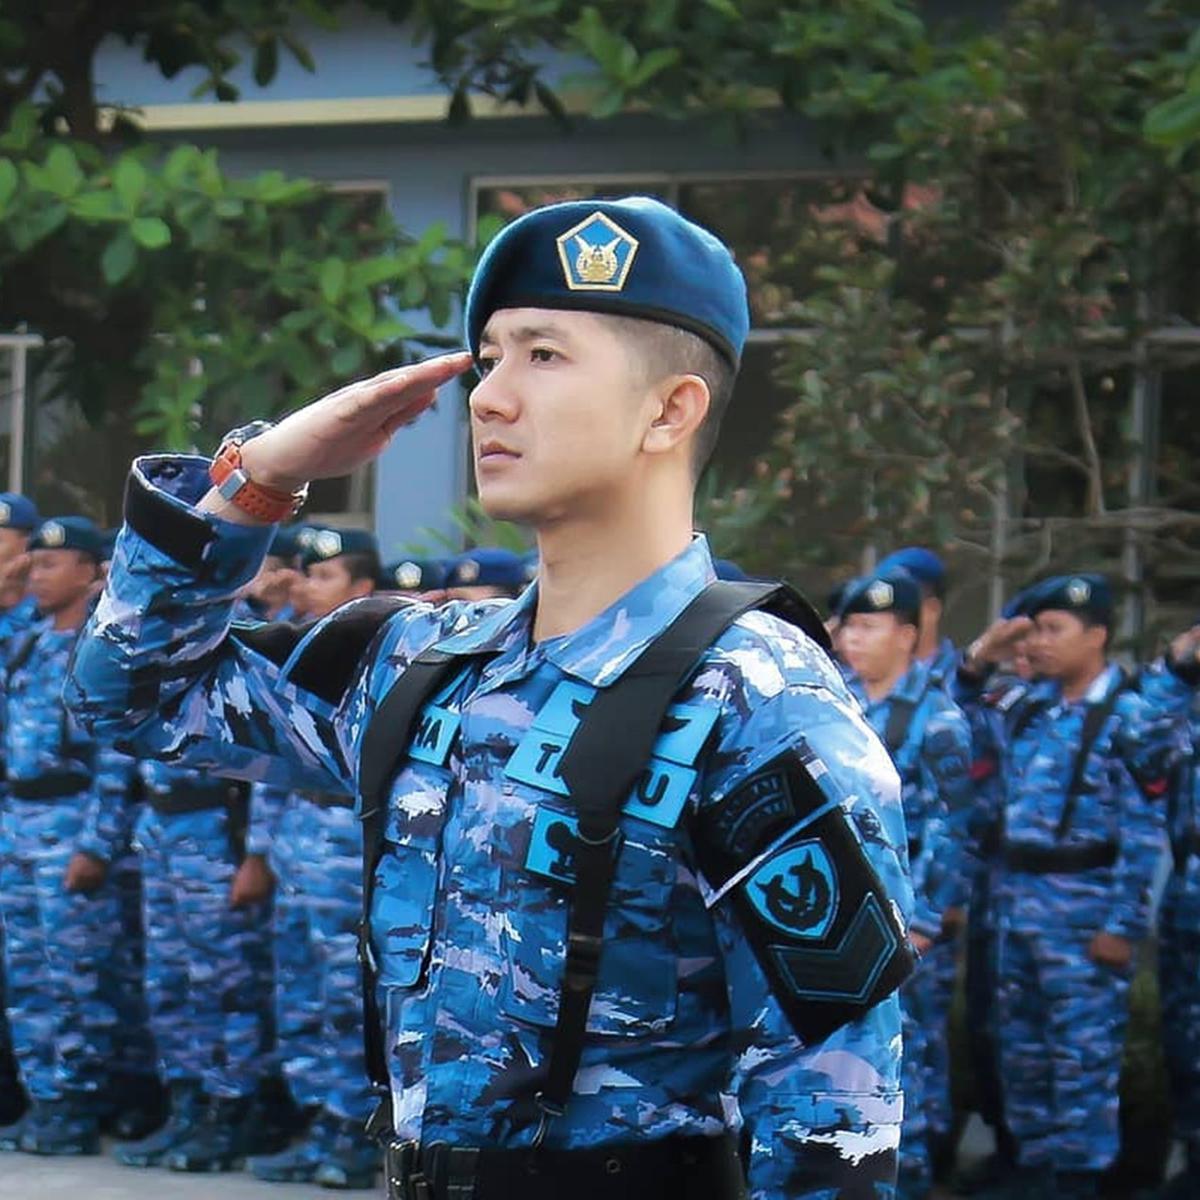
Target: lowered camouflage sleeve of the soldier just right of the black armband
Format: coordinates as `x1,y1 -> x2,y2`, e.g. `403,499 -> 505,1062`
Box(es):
912,694 -> 974,938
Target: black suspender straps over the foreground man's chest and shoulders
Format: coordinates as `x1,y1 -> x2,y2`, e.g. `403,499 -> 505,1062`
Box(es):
359,582 -> 828,1140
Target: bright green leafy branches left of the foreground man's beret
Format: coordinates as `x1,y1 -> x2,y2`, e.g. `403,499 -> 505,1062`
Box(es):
0,0 -> 470,508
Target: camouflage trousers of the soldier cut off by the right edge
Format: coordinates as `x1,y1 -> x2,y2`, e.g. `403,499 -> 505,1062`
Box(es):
1158,876 -> 1200,1146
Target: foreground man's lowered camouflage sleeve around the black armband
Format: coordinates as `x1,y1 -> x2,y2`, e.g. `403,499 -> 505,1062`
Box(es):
701,614 -> 912,1200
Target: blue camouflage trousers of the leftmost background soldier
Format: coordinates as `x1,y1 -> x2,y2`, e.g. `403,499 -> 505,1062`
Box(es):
0,799 -> 154,1106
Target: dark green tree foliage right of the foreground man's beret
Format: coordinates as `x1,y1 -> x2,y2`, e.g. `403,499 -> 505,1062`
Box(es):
416,0 -> 1200,638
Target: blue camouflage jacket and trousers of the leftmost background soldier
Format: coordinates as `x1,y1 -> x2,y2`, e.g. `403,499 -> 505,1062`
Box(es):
0,622 -> 154,1105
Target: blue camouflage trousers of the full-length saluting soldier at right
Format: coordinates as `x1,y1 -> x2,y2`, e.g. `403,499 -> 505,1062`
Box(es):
997,914 -> 1130,1171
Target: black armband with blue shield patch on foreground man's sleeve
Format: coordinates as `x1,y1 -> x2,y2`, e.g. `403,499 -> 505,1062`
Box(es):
696,746 -> 914,1045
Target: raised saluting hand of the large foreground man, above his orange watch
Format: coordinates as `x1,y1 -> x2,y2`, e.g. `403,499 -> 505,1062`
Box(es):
226,350 -> 472,492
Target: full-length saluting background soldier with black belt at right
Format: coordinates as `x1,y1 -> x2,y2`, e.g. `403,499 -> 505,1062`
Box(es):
960,575 -> 1187,1196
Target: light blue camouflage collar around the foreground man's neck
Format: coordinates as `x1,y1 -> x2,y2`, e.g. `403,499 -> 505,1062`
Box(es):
437,534 -> 716,688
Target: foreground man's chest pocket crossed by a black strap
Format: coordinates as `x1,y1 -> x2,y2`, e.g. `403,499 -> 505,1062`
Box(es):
500,822 -> 678,1037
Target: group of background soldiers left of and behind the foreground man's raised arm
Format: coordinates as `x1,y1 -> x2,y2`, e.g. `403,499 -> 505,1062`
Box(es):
0,493 -> 529,1188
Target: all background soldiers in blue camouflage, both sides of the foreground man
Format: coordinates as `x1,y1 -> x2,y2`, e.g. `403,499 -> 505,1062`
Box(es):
0,472 -> 1200,1196
